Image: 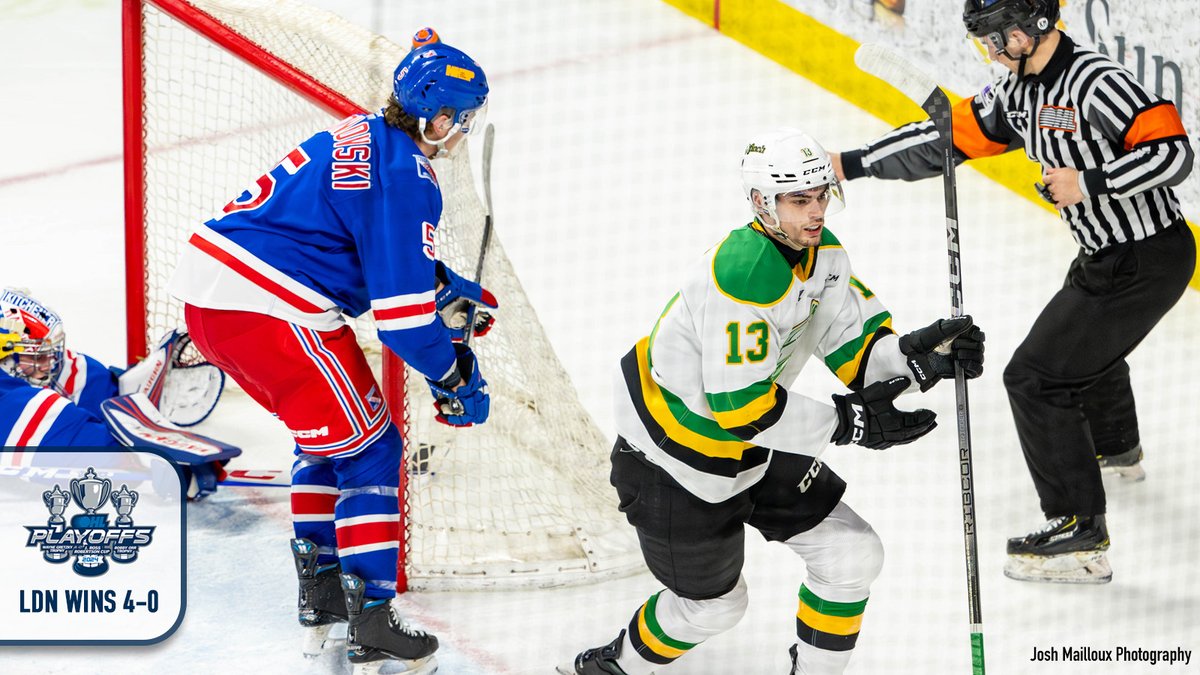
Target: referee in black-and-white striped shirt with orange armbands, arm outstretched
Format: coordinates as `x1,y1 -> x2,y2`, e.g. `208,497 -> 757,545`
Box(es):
833,0 -> 1196,584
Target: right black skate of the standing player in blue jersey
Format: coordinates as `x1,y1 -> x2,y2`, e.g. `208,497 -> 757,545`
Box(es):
342,566 -> 438,675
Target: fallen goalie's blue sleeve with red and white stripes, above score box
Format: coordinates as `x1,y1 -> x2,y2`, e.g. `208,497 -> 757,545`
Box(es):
0,371 -> 119,447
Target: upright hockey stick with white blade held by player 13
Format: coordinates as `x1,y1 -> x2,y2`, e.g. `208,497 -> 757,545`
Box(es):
854,44 -> 984,675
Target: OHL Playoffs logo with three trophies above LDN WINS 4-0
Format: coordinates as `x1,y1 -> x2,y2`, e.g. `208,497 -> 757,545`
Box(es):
25,466 -> 155,577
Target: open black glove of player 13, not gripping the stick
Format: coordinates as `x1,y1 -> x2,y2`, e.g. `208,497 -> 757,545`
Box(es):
830,377 -> 937,450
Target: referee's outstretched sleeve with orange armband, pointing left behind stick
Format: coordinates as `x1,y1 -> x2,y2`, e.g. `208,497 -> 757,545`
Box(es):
841,74 -> 1021,180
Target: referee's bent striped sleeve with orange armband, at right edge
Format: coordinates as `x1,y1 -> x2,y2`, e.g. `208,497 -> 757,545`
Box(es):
1082,68 -> 1195,199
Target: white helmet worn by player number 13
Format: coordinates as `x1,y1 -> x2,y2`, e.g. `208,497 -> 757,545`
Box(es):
742,127 -> 846,235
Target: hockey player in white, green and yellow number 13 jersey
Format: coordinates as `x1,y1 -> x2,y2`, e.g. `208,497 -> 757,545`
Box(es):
559,129 -> 984,675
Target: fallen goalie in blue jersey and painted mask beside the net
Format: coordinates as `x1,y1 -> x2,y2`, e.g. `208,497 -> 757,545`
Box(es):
0,288 -> 241,500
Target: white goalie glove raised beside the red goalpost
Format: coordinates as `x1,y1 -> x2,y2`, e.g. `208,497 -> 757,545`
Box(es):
118,330 -> 224,426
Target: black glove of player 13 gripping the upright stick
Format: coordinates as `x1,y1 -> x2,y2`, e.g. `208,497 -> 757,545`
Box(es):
900,316 -> 984,392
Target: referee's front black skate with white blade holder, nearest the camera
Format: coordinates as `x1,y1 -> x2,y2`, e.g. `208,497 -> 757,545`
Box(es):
1004,515 -> 1112,584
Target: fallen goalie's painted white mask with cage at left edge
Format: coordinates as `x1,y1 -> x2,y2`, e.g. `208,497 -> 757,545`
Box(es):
0,288 -> 66,387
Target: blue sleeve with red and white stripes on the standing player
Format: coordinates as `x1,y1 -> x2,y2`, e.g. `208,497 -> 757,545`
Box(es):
355,163 -> 455,380
